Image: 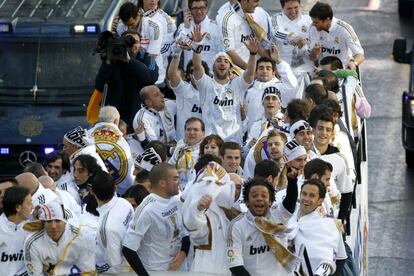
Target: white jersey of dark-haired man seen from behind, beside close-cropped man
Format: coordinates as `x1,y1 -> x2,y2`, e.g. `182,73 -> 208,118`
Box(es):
96,196 -> 134,274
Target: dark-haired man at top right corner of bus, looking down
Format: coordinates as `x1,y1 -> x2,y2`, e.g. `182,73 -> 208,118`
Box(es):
308,2 -> 365,70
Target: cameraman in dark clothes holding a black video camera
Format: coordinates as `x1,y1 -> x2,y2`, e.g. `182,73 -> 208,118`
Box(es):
87,31 -> 158,128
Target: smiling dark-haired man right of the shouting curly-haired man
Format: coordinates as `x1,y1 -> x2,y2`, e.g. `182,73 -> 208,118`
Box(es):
294,179 -> 343,275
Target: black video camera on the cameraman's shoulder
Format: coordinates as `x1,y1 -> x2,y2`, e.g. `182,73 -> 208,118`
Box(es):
95,31 -> 136,61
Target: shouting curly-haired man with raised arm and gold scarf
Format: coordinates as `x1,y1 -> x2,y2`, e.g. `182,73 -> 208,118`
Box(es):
227,177 -> 298,275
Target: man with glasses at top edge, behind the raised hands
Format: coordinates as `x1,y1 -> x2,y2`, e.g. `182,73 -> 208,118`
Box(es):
177,0 -> 223,68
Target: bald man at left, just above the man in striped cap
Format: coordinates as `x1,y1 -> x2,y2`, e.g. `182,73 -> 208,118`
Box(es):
16,172 -> 56,206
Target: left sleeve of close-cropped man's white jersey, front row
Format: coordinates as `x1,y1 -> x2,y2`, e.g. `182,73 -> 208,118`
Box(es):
122,206 -> 151,251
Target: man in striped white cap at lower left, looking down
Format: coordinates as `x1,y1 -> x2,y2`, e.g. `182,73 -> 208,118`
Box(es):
24,200 -> 96,275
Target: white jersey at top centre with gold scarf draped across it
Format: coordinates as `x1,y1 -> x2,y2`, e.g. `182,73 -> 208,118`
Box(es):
223,7 -> 270,63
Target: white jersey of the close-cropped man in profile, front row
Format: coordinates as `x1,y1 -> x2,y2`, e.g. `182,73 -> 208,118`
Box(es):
122,193 -> 187,271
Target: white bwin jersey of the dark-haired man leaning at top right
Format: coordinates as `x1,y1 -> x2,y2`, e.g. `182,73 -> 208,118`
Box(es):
308,17 -> 364,67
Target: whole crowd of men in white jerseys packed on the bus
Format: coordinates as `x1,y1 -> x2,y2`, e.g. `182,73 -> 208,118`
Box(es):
0,0 -> 371,275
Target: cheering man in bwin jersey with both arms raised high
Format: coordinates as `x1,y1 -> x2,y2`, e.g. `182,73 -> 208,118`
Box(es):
193,25 -> 259,144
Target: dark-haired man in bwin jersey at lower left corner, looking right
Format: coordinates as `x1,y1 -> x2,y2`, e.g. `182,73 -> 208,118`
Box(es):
0,186 -> 33,275
